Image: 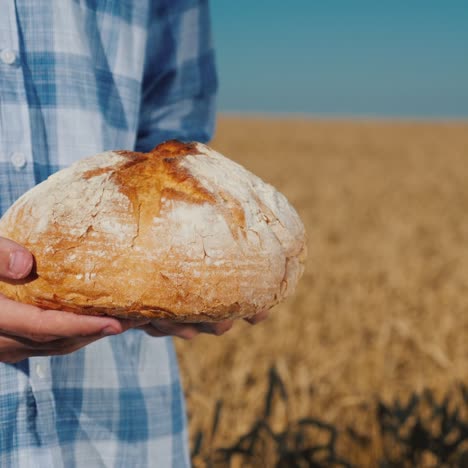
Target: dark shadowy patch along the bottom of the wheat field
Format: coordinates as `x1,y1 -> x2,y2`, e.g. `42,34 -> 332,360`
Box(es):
192,367 -> 468,468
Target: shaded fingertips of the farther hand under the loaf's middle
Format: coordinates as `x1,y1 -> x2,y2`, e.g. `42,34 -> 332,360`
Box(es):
140,310 -> 269,340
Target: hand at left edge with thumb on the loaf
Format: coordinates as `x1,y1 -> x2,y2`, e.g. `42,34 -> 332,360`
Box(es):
0,237 -> 147,363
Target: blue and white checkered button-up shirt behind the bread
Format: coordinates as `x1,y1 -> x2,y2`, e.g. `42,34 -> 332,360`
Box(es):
0,0 -> 216,468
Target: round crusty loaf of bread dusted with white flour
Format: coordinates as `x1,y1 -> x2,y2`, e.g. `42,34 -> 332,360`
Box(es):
0,141 -> 305,322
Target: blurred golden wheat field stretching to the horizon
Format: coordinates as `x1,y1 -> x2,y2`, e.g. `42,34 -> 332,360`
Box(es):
176,116 -> 468,467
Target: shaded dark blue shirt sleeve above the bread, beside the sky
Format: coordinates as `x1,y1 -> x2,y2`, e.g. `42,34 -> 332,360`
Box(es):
136,0 -> 218,151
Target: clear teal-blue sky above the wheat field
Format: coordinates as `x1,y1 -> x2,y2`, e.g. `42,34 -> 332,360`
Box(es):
211,0 -> 468,118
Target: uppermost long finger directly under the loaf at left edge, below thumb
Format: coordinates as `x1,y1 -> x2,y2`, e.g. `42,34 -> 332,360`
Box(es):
0,296 -> 125,341
